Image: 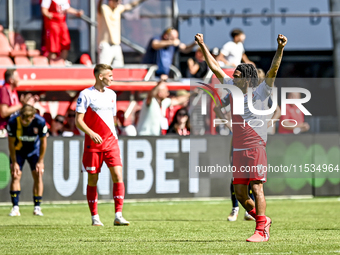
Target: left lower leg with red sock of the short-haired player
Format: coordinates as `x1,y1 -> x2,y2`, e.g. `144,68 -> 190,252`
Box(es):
86,173 -> 104,226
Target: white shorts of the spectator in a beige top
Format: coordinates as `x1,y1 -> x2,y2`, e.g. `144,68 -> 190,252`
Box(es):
98,42 -> 124,67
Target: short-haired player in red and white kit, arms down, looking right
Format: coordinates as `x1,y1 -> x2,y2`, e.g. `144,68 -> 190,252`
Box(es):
76,64 -> 130,226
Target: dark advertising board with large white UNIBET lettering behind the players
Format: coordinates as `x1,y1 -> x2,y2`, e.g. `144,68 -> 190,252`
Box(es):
0,135 -> 340,202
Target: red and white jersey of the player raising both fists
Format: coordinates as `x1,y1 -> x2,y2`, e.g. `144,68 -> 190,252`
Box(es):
224,75 -> 272,150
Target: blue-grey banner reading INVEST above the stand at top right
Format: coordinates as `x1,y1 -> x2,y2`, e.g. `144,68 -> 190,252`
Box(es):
177,0 -> 333,51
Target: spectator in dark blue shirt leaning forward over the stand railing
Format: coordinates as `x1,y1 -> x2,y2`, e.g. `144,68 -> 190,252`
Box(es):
142,27 -> 196,80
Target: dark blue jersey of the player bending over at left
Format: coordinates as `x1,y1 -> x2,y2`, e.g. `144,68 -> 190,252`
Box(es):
7,114 -> 47,157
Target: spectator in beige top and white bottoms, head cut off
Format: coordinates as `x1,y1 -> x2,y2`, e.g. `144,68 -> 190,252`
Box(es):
97,0 -> 146,67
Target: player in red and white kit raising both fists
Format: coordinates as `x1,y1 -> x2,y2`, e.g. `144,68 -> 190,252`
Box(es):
195,34 -> 287,242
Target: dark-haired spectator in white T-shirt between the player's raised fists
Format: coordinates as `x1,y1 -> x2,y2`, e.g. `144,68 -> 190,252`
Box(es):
217,29 -> 255,67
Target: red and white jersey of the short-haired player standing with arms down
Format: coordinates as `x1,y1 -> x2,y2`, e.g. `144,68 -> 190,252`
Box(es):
76,86 -> 118,152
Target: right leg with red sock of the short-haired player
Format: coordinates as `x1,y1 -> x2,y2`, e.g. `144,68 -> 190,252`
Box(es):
109,166 -> 130,226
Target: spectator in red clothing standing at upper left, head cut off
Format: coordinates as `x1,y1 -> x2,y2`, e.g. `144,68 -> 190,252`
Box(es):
41,0 -> 83,64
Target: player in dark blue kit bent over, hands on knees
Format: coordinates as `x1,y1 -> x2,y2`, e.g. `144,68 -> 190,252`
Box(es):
7,105 -> 47,216
